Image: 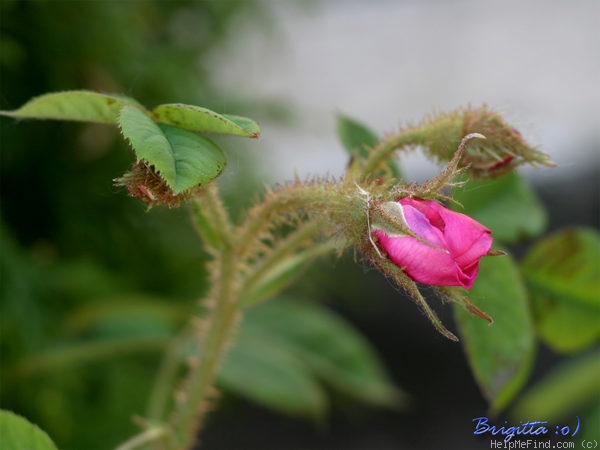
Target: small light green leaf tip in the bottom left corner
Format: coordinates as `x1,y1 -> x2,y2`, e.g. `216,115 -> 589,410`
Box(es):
0,410 -> 57,450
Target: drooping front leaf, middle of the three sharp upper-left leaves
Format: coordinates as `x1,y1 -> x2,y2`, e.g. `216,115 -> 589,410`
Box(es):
119,106 -> 226,194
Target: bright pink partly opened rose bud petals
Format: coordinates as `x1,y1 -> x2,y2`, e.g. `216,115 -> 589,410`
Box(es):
371,197 -> 493,289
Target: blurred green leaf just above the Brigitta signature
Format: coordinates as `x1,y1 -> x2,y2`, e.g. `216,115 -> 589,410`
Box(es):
511,351 -> 600,423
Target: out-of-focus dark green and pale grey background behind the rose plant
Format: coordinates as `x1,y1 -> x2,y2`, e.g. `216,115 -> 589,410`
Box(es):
0,0 -> 600,449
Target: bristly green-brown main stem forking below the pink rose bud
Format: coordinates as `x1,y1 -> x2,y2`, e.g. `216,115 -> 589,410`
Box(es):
149,156 -> 404,449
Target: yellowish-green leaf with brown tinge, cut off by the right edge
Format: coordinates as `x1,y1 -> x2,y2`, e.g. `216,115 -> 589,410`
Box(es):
521,228 -> 600,352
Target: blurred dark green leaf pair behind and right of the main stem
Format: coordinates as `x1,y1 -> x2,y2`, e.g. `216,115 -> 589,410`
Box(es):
219,298 -> 404,418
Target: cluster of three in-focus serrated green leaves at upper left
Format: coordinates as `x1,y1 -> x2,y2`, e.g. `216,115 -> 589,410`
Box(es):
0,91 -> 260,196
